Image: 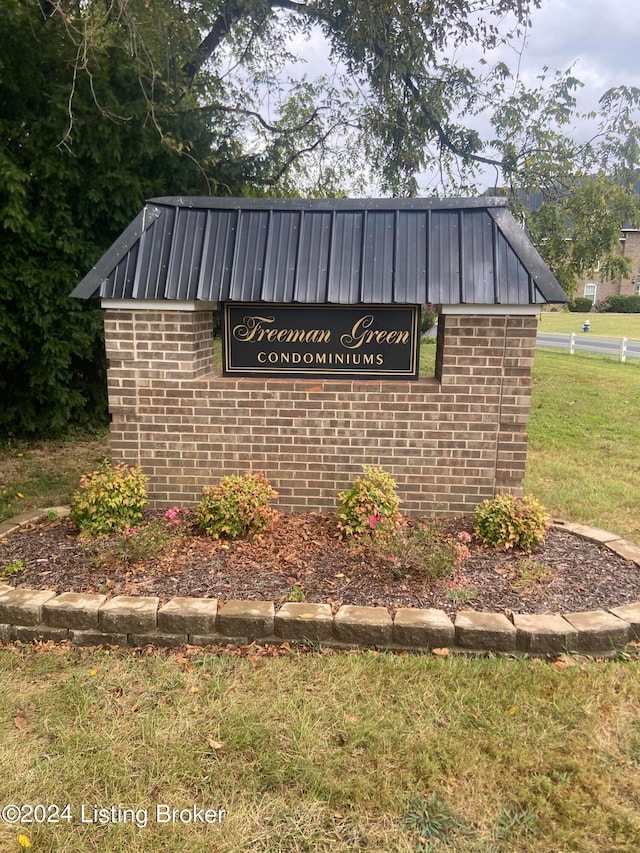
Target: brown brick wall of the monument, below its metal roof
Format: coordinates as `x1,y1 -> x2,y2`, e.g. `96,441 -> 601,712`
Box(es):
105,308 -> 537,515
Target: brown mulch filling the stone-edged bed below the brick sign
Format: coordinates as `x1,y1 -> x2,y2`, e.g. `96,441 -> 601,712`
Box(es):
0,513 -> 640,615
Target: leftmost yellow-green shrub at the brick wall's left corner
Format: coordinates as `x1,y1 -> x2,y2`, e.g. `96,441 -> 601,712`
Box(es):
70,460 -> 147,536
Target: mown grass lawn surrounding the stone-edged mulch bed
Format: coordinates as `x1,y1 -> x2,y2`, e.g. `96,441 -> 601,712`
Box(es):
0,350 -> 640,853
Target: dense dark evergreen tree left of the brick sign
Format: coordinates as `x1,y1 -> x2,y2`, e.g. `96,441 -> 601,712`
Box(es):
0,0 -> 251,436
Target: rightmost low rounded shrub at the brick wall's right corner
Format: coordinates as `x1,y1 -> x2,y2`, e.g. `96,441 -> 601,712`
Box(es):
473,494 -> 549,552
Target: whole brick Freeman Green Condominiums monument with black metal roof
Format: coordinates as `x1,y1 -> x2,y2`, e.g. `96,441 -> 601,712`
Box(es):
72,198 -> 567,515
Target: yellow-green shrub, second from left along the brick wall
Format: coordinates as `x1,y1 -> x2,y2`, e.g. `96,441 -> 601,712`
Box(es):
197,471 -> 278,539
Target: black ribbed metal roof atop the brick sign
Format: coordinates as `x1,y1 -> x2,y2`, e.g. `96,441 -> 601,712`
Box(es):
71,198 -> 567,305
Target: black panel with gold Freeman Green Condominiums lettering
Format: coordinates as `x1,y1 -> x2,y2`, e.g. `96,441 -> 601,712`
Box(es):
222,303 -> 420,379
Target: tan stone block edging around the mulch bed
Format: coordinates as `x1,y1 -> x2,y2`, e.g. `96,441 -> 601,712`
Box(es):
0,507 -> 640,655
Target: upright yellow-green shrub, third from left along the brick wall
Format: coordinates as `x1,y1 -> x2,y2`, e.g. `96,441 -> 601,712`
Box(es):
338,465 -> 400,536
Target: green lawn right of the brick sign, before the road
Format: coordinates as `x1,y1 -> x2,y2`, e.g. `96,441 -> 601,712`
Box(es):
525,350 -> 640,542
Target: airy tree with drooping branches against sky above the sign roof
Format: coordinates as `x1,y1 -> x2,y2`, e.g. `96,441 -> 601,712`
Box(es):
42,0 -> 541,195
